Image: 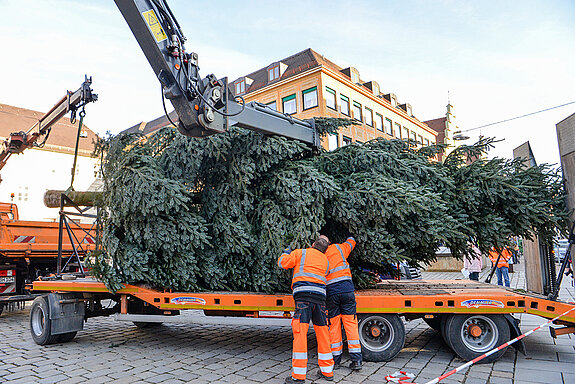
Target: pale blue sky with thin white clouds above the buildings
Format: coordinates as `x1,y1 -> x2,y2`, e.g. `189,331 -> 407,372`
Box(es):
0,0 -> 575,163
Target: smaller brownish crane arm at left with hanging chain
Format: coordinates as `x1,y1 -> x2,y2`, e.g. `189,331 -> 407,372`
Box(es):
0,76 -> 98,176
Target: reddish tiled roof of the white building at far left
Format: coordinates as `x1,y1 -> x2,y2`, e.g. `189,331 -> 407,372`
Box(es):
0,103 -> 98,155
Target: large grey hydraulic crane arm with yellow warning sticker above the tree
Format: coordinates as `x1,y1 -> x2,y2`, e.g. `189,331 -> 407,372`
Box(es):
114,0 -> 320,147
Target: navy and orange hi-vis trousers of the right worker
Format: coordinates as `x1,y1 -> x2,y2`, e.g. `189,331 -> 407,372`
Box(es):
327,293 -> 362,364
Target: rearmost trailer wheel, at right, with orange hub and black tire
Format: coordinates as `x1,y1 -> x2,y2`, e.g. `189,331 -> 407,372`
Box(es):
445,314 -> 511,364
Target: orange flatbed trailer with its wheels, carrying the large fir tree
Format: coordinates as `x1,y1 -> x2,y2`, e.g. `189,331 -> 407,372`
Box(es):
31,278 -> 575,362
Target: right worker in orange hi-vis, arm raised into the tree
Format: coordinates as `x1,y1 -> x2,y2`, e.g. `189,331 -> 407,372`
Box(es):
325,237 -> 362,371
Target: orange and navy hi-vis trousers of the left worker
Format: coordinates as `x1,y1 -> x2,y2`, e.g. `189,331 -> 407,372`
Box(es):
291,300 -> 333,380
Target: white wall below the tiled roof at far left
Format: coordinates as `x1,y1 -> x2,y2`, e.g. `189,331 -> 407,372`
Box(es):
0,149 -> 98,221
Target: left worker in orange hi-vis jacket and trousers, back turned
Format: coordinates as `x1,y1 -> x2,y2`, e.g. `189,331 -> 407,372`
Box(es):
278,235 -> 333,383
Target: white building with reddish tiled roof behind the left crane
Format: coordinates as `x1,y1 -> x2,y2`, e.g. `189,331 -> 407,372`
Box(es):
0,104 -> 101,221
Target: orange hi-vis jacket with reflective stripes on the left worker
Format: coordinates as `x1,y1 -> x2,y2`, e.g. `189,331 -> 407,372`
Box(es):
278,248 -> 329,296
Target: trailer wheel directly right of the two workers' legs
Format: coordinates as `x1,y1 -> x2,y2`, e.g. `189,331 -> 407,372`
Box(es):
359,314 -> 405,362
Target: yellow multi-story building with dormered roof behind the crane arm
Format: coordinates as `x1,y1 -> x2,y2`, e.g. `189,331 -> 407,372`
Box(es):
230,49 -> 437,150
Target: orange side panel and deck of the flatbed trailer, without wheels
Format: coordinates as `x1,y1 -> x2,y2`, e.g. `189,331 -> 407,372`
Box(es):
33,279 -> 575,324
